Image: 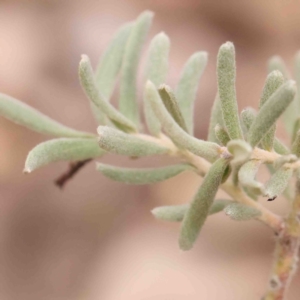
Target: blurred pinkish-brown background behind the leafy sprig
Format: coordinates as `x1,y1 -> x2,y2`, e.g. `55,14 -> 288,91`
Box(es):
0,0 -> 300,300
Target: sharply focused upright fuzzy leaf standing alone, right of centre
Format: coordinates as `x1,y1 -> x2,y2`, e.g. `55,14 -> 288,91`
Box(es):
217,42 -> 243,140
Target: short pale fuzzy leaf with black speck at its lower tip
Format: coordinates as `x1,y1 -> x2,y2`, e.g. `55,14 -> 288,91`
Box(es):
265,166 -> 293,200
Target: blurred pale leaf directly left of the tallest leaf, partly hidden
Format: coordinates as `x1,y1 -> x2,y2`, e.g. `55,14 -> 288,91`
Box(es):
90,23 -> 132,125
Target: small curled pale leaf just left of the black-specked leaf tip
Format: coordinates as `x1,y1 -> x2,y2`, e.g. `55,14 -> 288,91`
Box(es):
238,160 -> 265,195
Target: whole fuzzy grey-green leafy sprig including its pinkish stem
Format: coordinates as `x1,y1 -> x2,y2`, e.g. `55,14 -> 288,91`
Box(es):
0,12 -> 300,300
